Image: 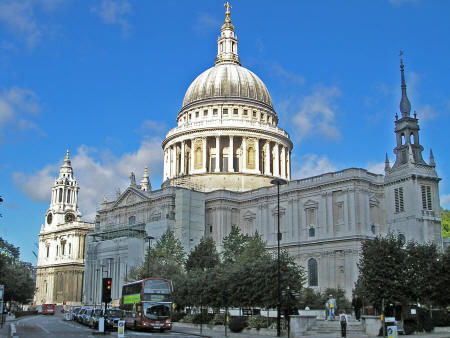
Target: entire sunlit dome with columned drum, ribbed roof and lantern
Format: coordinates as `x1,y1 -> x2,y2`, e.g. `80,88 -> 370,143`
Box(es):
162,3 -> 292,191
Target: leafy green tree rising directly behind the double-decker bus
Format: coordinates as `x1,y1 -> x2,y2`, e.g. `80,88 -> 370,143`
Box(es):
127,229 -> 186,281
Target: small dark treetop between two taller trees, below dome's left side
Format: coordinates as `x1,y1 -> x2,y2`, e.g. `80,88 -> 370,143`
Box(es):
186,237 -> 220,271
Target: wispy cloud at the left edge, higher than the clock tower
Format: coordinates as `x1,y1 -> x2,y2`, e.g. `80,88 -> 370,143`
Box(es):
0,87 -> 44,143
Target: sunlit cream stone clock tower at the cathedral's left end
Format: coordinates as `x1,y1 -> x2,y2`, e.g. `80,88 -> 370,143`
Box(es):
34,151 -> 94,305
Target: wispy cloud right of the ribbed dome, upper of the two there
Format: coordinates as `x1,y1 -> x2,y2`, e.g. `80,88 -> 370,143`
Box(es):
293,87 -> 341,141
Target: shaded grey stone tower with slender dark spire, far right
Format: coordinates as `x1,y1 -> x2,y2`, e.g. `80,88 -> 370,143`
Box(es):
385,52 -> 442,245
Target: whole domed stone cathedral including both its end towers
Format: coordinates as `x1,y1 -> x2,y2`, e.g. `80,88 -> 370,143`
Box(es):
38,7 -> 442,305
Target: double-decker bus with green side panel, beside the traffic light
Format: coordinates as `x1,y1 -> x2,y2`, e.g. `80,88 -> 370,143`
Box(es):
120,277 -> 173,332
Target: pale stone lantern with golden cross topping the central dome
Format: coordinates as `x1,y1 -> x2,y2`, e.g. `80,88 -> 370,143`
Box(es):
214,1 -> 241,65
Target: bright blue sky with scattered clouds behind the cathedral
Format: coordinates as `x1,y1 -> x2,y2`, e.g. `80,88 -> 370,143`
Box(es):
0,0 -> 450,263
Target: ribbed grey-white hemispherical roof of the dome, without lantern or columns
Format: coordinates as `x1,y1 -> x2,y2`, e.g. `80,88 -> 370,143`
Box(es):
182,62 -> 273,109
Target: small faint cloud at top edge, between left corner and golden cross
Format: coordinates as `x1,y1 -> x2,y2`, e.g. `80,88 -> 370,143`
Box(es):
91,0 -> 131,34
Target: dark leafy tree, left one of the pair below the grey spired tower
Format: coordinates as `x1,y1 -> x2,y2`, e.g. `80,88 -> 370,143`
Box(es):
357,234 -> 407,310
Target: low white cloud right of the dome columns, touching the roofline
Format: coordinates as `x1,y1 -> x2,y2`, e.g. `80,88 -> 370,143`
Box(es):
292,154 -> 337,179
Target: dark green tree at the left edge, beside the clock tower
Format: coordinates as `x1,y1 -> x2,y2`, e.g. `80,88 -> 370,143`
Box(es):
0,238 -> 34,303
